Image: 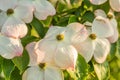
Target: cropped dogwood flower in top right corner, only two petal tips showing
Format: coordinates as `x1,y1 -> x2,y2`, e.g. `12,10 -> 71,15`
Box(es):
90,0 -> 120,12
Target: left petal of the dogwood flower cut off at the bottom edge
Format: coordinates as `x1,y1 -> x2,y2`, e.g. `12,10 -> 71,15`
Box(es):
22,66 -> 44,80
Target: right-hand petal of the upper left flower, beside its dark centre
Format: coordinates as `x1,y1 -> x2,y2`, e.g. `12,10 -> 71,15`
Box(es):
14,6 -> 33,23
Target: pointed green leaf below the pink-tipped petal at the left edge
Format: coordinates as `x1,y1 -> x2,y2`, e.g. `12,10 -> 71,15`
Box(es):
12,50 -> 29,74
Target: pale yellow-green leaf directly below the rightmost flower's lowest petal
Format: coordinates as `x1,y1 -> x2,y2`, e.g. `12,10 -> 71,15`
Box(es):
93,62 -> 110,80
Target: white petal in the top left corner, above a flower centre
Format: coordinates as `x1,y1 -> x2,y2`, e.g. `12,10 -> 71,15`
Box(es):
0,0 -> 17,11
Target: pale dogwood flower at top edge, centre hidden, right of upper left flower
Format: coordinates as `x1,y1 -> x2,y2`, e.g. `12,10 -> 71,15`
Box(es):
19,0 -> 56,20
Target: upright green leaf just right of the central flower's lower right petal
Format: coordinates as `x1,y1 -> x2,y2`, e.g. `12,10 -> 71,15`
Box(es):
76,55 -> 88,80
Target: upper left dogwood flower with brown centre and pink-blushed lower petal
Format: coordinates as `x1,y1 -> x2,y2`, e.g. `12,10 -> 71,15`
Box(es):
0,0 -> 33,38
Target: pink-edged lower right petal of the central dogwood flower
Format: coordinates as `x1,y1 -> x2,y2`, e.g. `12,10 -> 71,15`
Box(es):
54,45 -> 77,70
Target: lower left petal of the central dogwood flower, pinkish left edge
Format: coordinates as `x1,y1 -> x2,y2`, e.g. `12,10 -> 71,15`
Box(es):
35,39 -> 56,63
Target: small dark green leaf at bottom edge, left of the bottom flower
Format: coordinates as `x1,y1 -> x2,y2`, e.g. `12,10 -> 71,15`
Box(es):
10,67 -> 22,80
